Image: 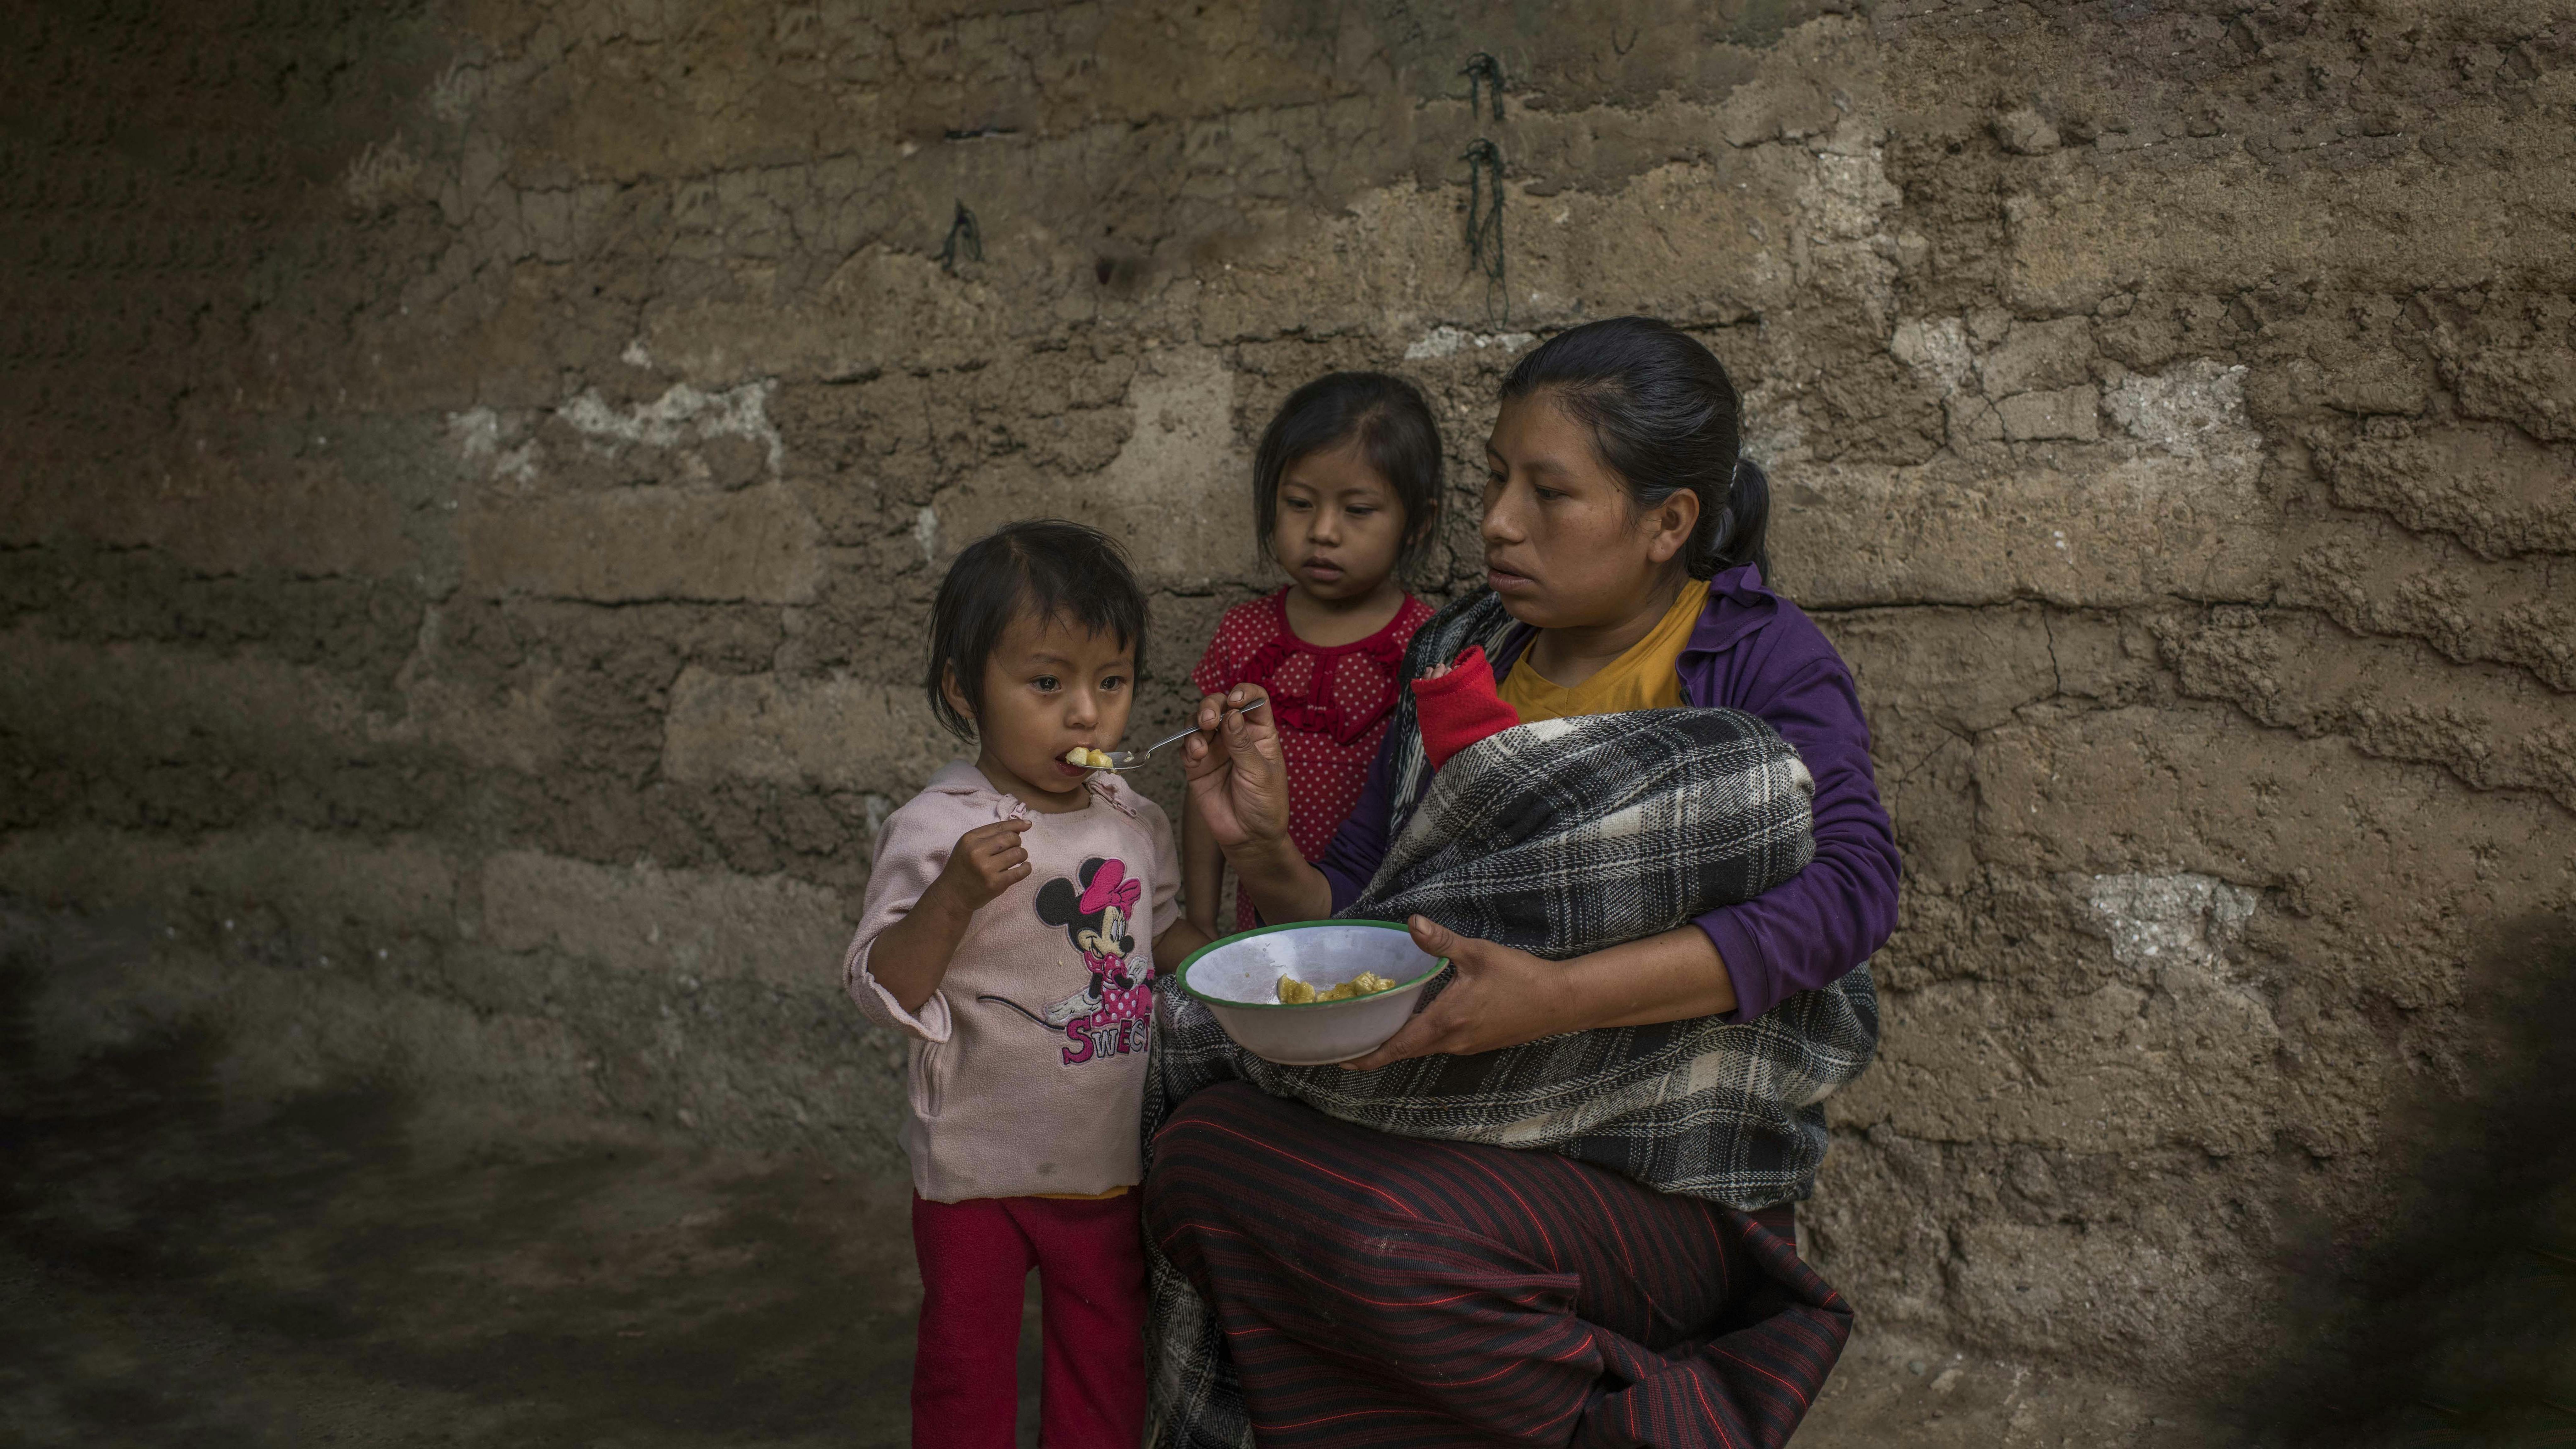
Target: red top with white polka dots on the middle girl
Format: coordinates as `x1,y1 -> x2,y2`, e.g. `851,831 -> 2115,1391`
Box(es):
1190,588 -> 1432,931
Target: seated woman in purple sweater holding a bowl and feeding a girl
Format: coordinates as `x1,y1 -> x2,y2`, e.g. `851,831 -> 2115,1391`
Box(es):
1146,317 -> 1896,1444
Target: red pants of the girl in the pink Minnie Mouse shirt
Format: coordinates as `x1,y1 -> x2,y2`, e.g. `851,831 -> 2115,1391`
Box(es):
912,1191 -> 1144,1449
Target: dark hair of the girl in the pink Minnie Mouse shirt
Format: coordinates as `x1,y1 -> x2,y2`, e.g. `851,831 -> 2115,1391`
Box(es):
927,518 -> 1144,740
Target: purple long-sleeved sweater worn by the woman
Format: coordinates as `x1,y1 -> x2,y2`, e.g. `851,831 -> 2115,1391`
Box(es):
1316,565 -> 1896,1021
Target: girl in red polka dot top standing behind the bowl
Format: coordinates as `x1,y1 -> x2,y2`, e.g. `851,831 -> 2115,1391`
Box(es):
1182,371 -> 1440,936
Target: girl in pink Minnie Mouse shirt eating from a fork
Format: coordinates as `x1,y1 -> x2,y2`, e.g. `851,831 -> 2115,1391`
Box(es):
842,521 -> 1206,1449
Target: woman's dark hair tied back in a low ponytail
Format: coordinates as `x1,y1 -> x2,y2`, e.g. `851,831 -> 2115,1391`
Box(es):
1502,317 -> 1770,577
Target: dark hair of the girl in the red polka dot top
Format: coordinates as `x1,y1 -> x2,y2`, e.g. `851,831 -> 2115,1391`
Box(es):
1252,371 -> 1440,562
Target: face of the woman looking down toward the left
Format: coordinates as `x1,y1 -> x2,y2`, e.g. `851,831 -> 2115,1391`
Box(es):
1481,392 -> 1700,629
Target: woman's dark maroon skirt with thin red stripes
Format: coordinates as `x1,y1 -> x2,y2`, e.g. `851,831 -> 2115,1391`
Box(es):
1144,1083 -> 1852,1449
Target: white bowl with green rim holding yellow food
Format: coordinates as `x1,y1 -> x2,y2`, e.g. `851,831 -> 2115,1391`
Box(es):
1180,921 -> 1448,1067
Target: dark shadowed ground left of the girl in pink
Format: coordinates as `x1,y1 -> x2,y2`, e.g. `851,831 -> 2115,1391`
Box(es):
0,967 -> 1035,1446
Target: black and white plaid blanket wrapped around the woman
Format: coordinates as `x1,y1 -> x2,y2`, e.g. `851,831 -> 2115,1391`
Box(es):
1144,593 -> 1878,1449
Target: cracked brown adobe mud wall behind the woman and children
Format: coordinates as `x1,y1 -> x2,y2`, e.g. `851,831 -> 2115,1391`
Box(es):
0,0 -> 2576,1382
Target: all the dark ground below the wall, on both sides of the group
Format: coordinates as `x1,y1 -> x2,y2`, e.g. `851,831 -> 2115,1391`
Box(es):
35,907 -> 2576,1449
